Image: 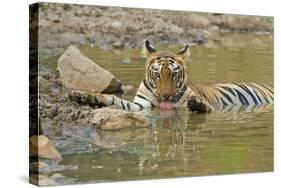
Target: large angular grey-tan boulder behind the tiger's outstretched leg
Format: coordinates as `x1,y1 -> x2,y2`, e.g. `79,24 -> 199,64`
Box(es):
57,46 -> 122,93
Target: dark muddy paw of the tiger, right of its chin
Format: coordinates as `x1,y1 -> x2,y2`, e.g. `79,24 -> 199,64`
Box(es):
187,96 -> 214,113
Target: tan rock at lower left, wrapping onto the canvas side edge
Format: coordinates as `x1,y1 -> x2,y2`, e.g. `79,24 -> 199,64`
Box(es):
29,135 -> 62,161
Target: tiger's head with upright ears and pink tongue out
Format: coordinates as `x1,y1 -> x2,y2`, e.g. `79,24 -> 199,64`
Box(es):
143,40 -> 190,106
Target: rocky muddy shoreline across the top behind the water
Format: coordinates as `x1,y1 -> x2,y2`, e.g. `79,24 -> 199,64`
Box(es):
38,3 -> 273,60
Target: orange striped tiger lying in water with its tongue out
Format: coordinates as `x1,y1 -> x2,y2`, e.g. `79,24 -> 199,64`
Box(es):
71,40 -> 274,113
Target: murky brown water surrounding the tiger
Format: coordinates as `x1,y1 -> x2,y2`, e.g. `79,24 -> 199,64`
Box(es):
39,34 -> 274,184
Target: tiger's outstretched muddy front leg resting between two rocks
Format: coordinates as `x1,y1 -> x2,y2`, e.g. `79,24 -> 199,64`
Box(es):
69,91 -> 143,111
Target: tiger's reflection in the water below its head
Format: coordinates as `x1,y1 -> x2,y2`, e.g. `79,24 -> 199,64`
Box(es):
145,110 -> 206,155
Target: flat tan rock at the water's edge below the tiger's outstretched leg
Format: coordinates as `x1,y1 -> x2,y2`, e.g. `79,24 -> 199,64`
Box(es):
92,108 -> 151,130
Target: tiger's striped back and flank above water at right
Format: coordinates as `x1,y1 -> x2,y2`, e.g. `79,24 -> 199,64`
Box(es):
187,82 -> 274,108
